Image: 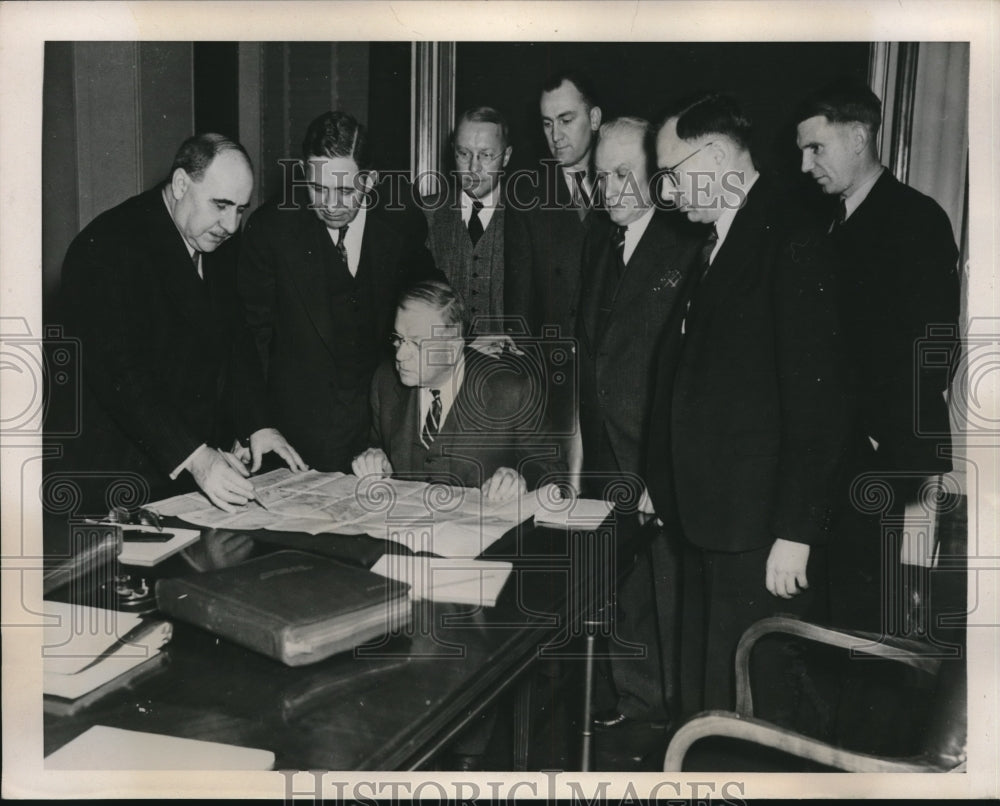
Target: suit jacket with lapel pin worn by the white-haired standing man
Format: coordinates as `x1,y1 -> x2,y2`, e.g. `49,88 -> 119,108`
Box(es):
576,210 -> 700,476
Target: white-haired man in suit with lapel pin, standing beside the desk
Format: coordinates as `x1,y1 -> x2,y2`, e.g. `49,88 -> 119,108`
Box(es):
576,118 -> 699,740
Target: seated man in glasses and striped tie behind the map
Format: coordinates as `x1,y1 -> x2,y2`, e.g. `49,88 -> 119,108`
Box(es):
352,280 -> 566,503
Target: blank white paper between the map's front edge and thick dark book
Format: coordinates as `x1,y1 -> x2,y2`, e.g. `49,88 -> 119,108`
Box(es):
372,554 -> 513,607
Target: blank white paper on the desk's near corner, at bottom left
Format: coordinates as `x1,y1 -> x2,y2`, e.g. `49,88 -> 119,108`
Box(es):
45,725 -> 274,770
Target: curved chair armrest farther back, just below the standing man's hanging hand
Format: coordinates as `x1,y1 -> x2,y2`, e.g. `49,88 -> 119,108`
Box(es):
736,616 -> 941,717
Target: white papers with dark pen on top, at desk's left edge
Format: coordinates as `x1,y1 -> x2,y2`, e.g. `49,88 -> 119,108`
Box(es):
42,602 -> 173,699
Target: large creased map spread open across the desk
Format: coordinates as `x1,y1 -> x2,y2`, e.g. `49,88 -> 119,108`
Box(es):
149,468 -> 564,557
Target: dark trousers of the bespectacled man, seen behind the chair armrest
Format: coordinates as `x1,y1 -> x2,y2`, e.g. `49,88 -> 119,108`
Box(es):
680,543 -> 826,726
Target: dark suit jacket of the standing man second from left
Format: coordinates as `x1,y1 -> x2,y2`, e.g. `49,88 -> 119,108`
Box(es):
239,196 -> 440,471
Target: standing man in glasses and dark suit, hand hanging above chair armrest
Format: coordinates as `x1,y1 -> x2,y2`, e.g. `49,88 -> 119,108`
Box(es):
647,94 -> 848,721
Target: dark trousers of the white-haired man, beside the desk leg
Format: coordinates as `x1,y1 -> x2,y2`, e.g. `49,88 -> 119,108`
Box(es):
609,527 -> 680,722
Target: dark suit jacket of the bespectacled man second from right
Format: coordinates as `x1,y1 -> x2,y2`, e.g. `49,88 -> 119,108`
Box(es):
647,177 -> 850,552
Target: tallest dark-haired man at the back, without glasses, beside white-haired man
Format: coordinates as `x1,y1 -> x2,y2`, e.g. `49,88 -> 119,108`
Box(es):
505,70 -> 603,486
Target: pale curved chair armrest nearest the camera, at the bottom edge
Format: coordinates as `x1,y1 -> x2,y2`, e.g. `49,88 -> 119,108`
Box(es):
663,711 -> 944,772
